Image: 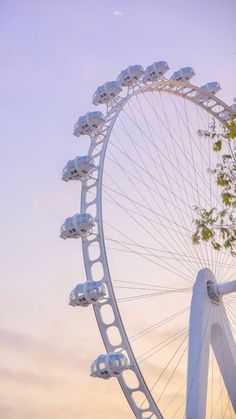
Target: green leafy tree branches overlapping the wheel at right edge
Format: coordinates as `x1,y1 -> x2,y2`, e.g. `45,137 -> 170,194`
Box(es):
192,115 -> 236,256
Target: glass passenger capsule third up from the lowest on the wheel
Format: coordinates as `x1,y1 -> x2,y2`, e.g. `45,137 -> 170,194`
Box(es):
60,214 -> 95,240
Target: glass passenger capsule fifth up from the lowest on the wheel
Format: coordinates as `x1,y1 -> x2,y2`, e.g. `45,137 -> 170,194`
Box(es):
74,111 -> 105,137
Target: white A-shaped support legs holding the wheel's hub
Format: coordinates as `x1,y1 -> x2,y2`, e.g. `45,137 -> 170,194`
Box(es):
186,268 -> 236,419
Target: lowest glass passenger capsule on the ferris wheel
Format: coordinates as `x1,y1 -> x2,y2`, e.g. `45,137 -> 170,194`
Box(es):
91,352 -> 129,380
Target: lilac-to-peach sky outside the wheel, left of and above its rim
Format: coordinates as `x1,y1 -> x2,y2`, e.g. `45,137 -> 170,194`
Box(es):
0,0 -> 236,419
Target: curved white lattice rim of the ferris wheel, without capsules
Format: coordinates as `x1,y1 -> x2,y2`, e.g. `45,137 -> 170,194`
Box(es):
81,80 -> 233,419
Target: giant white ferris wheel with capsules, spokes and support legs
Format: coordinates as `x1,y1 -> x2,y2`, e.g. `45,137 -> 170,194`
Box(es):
60,61 -> 236,419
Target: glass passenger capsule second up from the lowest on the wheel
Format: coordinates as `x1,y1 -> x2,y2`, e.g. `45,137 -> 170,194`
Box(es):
69,281 -> 106,307
